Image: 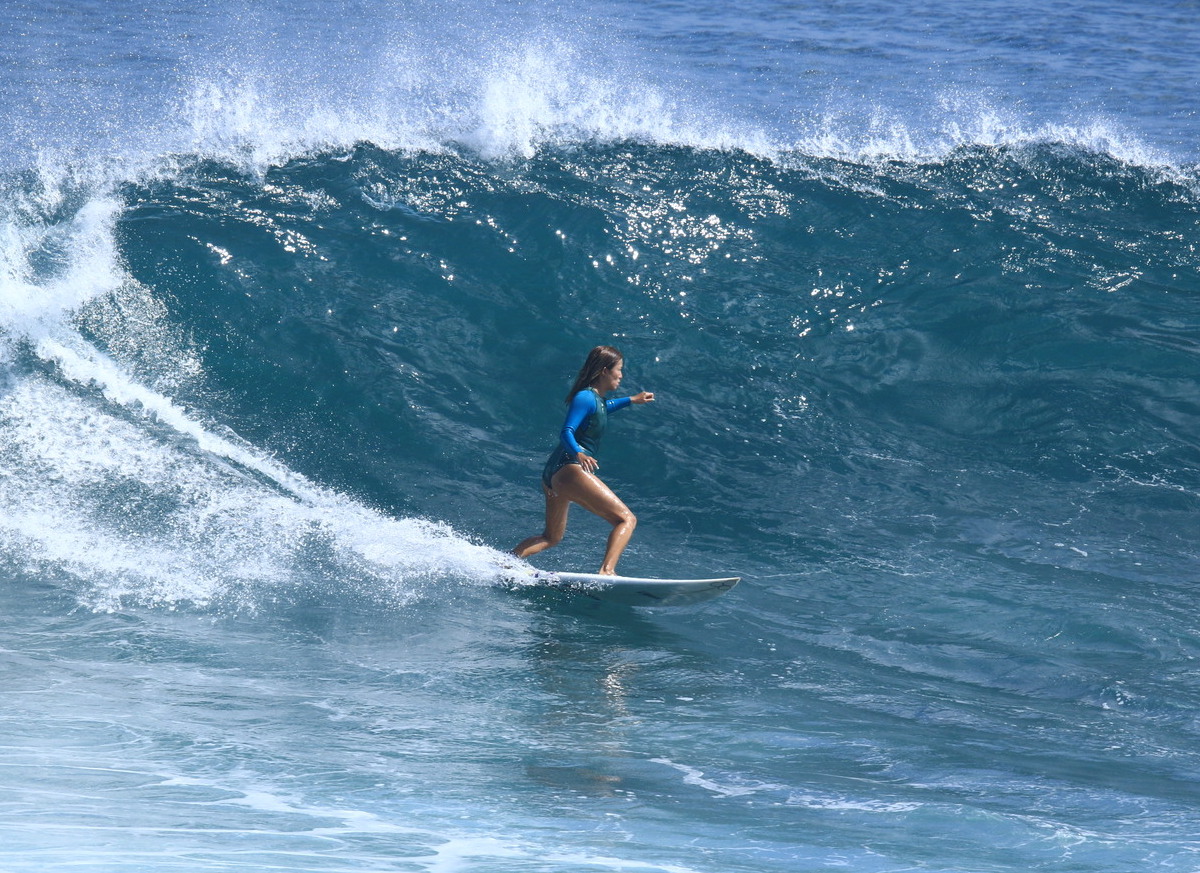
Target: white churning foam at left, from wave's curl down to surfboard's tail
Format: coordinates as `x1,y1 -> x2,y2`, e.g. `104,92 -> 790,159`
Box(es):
0,177 -> 499,609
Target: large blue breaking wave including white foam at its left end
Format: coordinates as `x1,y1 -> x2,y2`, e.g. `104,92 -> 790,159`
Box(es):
0,133 -> 1200,607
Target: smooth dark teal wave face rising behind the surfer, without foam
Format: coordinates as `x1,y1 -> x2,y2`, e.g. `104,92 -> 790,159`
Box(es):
103,143 -> 1198,587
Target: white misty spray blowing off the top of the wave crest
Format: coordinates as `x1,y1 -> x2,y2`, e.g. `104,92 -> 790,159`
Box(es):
7,22 -> 1187,190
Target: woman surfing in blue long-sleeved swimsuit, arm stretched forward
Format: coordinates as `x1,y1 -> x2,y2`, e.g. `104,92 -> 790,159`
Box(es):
512,345 -> 654,576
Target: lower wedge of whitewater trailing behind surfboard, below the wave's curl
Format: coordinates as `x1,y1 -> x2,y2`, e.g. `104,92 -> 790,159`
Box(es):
0,341 -> 499,609
